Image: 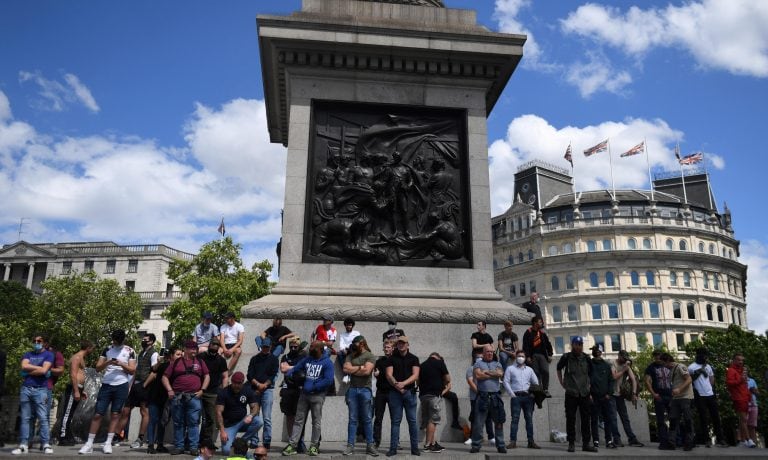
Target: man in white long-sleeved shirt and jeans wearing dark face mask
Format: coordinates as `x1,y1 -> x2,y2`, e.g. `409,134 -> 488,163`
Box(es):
504,350 -> 541,449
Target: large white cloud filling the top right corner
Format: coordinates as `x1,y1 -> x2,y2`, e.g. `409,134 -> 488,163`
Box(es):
561,0 -> 768,78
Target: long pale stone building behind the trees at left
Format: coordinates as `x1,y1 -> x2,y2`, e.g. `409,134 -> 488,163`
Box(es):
0,241 -> 193,345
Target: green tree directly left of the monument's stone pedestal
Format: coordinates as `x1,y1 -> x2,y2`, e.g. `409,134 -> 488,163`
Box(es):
163,237 -> 272,344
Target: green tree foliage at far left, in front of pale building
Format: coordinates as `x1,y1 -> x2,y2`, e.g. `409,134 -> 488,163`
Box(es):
0,272 -> 142,391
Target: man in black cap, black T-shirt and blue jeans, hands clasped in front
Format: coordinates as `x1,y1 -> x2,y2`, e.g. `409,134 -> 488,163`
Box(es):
386,336 -> 421,457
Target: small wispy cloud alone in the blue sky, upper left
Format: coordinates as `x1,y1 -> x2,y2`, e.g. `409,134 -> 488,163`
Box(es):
19,70 -> 100,113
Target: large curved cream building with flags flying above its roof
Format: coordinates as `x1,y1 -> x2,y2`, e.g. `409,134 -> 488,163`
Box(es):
492,161 -> 747,354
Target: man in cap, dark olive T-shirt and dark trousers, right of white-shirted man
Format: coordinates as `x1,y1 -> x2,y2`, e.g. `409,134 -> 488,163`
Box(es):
557,336 -> 597,452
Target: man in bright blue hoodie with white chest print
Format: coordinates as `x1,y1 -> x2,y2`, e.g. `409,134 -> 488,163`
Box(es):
282,340 -> 333,457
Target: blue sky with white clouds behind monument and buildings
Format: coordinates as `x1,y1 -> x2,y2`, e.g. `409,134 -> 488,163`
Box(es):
0,0 -> 768,333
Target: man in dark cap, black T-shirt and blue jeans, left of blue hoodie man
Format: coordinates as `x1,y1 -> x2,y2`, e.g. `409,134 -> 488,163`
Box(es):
247,337 -> 280,449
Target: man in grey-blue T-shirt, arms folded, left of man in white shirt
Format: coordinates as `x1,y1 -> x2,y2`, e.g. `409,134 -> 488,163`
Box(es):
469,345 -> 507,454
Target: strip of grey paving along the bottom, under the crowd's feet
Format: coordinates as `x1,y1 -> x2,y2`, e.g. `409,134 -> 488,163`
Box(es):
0,442 -> 768,460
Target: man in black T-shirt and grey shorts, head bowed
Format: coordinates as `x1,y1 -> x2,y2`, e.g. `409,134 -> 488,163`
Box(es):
419,352 -> 451,453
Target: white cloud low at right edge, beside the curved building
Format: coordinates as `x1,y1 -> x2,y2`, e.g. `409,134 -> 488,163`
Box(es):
739,240 -> 768,334
